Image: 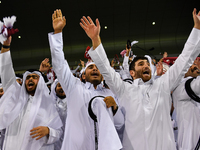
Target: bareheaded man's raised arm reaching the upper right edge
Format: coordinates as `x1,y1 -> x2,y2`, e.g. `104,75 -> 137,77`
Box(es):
163,9 -> 200,91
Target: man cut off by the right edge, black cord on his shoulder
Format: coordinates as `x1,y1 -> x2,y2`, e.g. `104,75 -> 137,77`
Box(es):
172,61 -> 200,150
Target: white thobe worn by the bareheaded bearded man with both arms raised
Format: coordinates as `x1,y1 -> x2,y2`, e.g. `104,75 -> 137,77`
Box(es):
89,29 -> 200,150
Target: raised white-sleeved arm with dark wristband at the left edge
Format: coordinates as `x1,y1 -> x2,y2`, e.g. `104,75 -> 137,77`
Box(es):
0,36 -> 16,91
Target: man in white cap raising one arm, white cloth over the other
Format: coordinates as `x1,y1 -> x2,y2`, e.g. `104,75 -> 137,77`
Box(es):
49,10 -> 122,150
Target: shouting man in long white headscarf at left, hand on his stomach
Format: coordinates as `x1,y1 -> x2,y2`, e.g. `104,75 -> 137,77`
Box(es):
0,37 -> 62,150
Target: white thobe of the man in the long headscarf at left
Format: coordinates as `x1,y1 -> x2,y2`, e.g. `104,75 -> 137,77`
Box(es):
0,51 -> 62,150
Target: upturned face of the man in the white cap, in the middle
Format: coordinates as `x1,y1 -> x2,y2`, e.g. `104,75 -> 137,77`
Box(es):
85,64 -> 102,86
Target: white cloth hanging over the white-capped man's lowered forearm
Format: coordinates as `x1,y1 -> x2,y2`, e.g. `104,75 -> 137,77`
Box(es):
92,97 -> 122,150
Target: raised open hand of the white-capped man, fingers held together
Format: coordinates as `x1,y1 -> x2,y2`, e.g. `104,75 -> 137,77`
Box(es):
52,9 -> 66,34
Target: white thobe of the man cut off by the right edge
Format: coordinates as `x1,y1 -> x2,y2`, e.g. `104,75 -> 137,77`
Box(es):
172,76 -> 200,150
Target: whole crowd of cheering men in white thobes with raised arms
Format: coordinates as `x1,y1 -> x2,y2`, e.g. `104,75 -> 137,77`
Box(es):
0,9 -> 200,150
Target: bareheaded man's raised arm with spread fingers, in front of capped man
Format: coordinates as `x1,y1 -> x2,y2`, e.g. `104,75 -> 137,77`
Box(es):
80,17 -> 124,98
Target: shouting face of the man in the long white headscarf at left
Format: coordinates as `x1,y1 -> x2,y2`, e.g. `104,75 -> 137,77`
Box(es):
25,73 -> 40,96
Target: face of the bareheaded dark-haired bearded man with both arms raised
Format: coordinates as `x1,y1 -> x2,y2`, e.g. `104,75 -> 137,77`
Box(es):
130,59 -> 151,82
